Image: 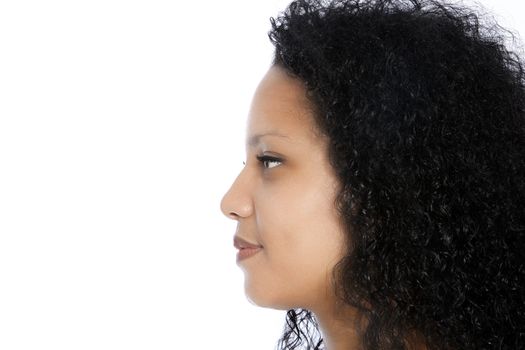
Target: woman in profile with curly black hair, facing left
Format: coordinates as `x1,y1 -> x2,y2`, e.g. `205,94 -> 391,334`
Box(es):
221,0 -> 525,350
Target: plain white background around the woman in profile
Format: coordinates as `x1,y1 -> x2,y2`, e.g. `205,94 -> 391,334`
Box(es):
0,0 -> 525,350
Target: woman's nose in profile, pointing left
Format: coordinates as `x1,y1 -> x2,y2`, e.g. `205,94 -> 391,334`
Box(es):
221,170 -> 253,220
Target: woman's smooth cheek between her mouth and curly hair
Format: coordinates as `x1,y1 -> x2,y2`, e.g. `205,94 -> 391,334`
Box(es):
256,178 -> 344,266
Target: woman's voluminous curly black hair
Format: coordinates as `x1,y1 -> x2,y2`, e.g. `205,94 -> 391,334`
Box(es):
269,0 -> 525,350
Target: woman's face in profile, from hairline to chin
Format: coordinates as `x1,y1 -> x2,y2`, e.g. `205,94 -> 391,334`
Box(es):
221,67 -> 345,310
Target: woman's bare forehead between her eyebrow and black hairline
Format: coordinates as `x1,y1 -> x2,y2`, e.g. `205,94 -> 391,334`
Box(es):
247,66 -> 315,143
